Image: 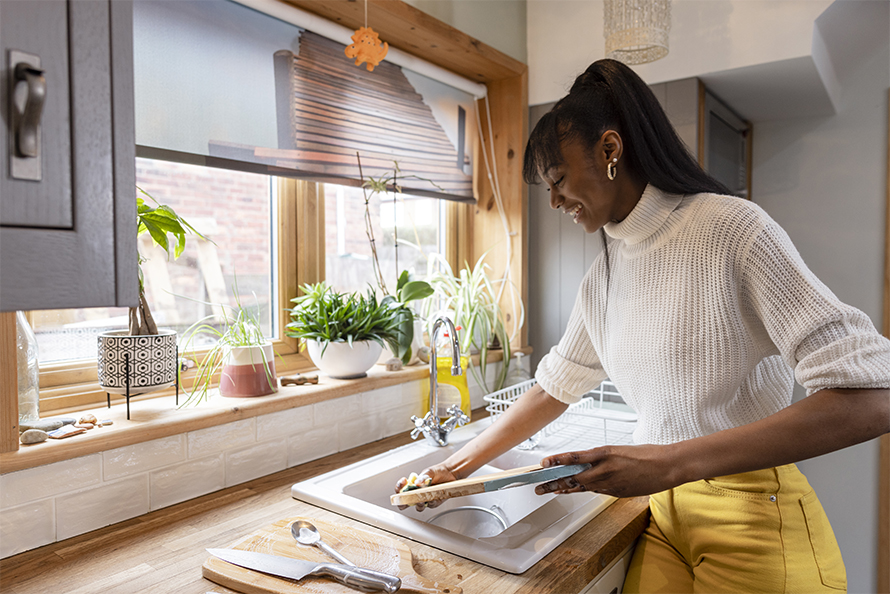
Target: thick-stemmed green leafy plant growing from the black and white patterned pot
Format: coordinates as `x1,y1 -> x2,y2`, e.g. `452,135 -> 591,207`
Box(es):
129,186 -> 212,336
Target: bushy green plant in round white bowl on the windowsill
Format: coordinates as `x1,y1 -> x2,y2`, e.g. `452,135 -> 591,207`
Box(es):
285,282 -> 405,379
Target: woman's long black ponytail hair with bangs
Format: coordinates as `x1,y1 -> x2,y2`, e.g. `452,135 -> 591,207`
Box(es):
522,59 -> 731,194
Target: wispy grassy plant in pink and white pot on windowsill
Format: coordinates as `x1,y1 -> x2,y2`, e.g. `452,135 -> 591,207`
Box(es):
183,279 -> 278,406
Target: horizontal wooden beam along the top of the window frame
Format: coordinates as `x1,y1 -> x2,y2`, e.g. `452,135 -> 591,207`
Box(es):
281,0 -> 527,83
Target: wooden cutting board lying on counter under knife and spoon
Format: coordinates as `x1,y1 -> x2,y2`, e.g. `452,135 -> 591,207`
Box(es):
201,517 -> 462,594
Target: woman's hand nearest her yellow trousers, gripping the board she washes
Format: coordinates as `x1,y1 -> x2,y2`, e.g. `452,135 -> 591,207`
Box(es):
535,445 -> 682,497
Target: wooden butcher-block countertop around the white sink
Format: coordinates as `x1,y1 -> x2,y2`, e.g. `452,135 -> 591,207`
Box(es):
0,424 -> 648,594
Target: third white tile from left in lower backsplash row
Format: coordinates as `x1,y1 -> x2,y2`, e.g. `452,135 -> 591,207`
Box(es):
149,454 -> 226,511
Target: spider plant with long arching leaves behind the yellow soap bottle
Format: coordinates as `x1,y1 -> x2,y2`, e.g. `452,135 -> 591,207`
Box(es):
427,252 -> 525,393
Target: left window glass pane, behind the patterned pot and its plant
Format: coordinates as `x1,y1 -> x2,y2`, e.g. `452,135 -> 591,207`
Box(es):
32,159 -> 279,364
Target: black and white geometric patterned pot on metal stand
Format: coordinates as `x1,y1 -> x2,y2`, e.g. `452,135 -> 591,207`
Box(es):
99,329 -> 176,396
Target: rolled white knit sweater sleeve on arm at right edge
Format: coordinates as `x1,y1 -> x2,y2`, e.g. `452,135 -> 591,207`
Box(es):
742,213 -> 890,395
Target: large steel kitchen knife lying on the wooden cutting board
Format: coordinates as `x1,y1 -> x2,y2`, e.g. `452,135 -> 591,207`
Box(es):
207,549 -> 402,594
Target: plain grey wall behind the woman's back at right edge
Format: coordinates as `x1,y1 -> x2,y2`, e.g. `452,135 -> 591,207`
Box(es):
752,38 -> 890,592
